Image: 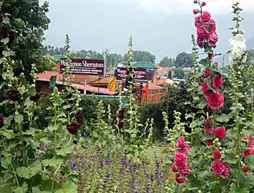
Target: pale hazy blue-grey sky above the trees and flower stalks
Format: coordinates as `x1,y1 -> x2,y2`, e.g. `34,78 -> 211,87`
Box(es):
41,0 -> 254,62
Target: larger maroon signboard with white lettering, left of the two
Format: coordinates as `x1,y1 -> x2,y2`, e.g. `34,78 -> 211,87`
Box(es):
60,58 -> 104,76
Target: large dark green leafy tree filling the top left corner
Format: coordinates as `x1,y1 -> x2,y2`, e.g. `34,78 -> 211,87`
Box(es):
0,0 -> 52,78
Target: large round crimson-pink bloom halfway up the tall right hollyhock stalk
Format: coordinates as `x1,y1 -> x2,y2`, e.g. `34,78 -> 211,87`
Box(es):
206,92 -> 224,110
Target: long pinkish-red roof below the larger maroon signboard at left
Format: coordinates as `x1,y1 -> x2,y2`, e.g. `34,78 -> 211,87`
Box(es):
37,71 -> 116,95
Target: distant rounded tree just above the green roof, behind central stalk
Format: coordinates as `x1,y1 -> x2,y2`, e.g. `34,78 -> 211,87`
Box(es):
123,50 -> 156,64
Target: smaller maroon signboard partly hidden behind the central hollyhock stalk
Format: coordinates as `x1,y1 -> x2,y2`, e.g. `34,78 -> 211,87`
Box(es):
116,67 -> 146,81
